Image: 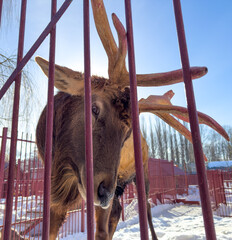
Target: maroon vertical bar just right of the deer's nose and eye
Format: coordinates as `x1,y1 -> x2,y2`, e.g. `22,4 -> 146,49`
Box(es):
125,0 -> 148,240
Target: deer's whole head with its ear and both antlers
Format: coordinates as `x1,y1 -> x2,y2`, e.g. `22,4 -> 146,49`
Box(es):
36,0 -> 228,208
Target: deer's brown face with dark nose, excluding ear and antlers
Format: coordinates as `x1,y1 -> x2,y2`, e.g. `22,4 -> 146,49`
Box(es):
70,89 -> 131,208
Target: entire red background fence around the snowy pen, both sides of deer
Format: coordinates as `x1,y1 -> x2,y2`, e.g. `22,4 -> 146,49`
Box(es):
0,128 -> 232,239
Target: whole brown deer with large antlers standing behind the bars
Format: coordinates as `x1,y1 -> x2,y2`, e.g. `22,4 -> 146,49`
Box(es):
36,0 -> 228,240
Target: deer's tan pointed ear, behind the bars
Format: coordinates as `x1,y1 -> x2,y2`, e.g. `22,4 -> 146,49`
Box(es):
35,57 -> 84,95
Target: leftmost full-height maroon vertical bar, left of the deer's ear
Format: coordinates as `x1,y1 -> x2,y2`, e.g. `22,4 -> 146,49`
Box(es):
4,0 -> 27,239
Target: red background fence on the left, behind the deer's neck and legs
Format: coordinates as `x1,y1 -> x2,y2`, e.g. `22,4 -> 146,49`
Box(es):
0,128 -> 85,239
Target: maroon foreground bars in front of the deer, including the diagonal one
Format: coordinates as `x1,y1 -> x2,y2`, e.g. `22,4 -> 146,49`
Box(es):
0,0 -> 225,240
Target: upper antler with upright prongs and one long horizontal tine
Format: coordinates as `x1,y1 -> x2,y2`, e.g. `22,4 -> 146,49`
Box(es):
91,0 -> 207,87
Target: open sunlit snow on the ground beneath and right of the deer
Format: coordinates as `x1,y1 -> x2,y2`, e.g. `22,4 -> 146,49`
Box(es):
60,202 -> 232,240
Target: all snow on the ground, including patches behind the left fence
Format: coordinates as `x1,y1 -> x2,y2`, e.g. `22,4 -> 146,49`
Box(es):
0,186 -> 232,240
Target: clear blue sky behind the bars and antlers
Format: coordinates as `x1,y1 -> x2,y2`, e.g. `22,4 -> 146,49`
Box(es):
0,0 -> 232,129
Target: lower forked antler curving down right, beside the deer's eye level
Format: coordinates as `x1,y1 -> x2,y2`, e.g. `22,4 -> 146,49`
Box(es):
139,90 -> 229,160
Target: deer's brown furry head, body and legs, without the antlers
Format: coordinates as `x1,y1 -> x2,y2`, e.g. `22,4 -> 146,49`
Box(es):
36,59 -> 157,240
